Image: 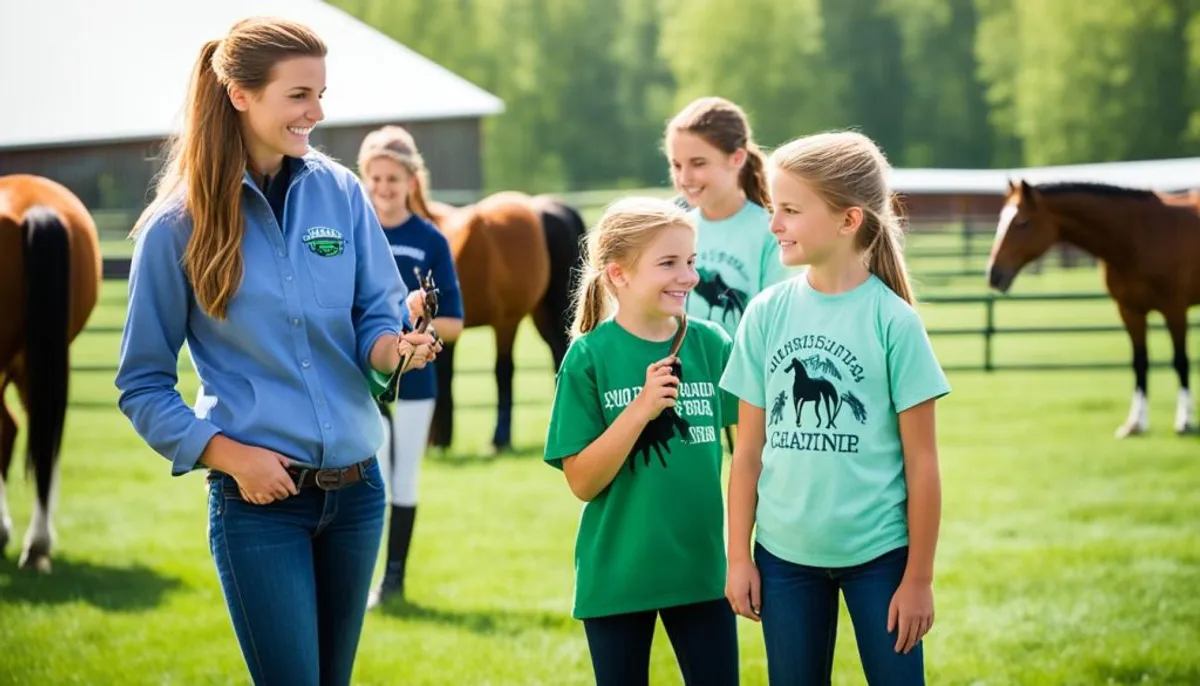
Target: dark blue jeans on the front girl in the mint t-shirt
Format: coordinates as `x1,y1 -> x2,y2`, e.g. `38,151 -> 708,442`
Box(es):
755,543 -> 925,686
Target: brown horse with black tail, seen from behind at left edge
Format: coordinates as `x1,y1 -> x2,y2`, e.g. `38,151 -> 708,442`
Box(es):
0,175 -> 101,572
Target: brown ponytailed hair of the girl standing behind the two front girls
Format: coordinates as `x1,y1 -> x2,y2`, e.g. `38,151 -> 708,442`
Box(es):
667,97 -> 770,211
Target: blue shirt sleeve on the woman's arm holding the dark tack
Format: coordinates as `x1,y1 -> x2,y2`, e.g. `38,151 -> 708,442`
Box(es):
350,183 -> 408,379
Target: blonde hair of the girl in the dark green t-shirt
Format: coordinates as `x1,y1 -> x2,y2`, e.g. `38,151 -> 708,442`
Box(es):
571,197 -> 696,339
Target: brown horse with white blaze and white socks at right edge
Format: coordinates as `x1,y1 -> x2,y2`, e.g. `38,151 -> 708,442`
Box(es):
988,181 -> 1200,438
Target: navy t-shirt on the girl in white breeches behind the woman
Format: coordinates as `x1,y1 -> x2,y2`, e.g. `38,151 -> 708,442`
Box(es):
383,215 -> 462,401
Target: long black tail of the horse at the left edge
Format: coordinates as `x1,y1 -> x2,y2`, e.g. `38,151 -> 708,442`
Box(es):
22,206 -> 71,509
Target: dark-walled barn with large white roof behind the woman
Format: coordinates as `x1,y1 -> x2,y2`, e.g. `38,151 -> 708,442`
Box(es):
0,0 -> 504,211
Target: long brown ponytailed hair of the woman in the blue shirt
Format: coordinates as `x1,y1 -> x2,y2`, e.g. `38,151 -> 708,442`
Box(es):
132,17 -> 325,319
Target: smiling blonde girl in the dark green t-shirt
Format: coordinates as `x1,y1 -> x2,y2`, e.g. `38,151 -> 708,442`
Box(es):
545,198 -> 738,686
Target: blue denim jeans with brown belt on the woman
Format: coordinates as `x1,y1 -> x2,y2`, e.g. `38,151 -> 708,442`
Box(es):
209,461 -> 385,686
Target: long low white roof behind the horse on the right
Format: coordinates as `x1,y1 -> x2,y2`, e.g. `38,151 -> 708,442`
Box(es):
892,157 -> 1200,195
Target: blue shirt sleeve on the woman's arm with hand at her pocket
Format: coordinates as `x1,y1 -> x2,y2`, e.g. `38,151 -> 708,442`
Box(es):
115,214 -> 220,476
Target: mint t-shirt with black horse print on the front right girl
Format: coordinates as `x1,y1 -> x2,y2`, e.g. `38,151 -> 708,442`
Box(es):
720,275 -> 950,567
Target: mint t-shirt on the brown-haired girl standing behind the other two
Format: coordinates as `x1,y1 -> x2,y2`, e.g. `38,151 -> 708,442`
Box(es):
688,200 -> 794,338
